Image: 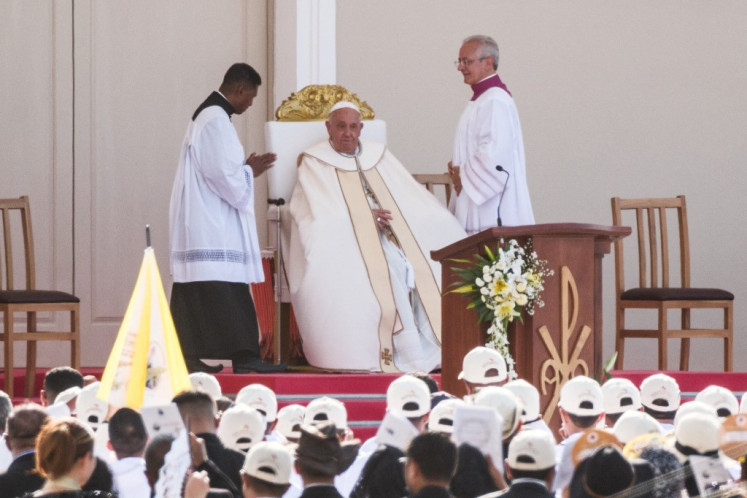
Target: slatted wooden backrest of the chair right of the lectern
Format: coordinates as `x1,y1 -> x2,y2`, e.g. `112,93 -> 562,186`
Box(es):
612,195 -> 690,293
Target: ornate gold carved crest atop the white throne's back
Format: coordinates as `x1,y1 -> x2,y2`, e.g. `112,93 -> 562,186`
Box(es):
275,85 -> 375,121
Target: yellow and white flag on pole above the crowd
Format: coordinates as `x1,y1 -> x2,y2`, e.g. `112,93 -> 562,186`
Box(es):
98,247 -> 192,410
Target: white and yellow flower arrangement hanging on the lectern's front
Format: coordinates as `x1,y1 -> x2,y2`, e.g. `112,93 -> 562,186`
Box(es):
452,239 -> 553,379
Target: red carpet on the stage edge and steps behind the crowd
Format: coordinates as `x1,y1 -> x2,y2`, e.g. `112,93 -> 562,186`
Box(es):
0,368 -> 747,439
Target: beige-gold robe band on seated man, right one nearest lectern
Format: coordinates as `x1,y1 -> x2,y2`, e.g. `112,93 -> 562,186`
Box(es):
363,168 -> 441,346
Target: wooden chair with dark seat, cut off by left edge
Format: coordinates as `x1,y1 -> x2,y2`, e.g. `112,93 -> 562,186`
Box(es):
0,196 -> 80,398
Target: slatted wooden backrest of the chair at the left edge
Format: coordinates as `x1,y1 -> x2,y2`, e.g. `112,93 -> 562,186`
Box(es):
0,195 -> 36,290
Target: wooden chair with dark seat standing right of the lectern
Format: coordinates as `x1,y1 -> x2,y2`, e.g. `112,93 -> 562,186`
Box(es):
612,195 -> 734,372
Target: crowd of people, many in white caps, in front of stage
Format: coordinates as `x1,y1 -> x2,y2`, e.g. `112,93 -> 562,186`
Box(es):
0,347 -> 747,498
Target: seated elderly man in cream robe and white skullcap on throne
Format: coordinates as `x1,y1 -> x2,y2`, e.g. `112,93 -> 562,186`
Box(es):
288,102 -> 465,372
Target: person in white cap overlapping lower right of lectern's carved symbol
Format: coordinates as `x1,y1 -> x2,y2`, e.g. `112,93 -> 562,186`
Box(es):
553,375 -> 604,493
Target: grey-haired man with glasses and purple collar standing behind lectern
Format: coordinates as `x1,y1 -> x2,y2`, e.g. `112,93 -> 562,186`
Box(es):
448,35 -> 534,234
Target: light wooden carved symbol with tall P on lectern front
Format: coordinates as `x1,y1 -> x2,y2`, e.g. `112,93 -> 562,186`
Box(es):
539,266 -> 591,422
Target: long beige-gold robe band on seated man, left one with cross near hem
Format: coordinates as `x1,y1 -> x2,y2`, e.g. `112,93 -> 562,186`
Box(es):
337,169 -> 402,373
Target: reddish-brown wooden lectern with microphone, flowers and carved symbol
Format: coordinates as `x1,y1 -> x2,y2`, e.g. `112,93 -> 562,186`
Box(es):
431,223 -> 631,427
